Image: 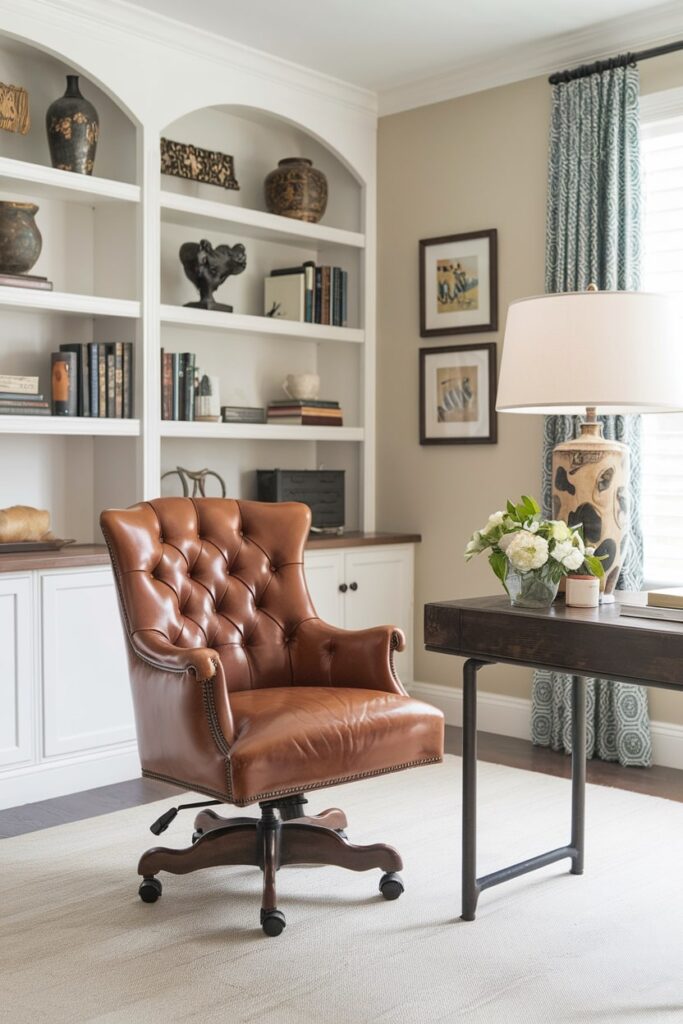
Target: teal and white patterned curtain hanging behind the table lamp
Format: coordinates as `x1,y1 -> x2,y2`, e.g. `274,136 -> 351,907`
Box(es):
531,67 -> 652,766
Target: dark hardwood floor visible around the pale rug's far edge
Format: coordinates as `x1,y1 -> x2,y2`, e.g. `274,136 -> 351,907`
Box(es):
0,726 -> 683,839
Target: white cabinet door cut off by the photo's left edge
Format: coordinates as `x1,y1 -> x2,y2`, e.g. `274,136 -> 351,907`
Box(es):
0,574 -> 34,767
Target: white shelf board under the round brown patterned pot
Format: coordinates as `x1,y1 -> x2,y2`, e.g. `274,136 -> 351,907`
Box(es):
161,191 -> 366,249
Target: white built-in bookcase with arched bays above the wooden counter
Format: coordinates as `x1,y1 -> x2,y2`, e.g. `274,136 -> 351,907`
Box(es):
0,0 -> 375,542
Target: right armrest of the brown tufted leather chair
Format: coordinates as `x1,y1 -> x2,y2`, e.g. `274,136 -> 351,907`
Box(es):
290,618 -> 405,694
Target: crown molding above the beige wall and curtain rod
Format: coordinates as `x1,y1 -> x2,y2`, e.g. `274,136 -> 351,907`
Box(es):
379,0 -> 683,117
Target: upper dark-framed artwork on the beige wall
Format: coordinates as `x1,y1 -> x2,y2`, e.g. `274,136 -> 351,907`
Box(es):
420,227 -> 498,338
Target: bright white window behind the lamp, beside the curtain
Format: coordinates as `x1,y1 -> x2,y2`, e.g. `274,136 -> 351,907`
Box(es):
641,114 -> 683,586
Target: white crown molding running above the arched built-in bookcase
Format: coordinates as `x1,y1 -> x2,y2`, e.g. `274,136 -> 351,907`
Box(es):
0,0 -> 377,120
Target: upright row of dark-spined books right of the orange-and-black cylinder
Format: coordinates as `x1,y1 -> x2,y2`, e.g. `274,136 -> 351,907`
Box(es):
59,341 -> 135,420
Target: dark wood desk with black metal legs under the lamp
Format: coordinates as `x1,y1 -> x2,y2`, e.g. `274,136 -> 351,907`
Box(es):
425,594 -> 683,921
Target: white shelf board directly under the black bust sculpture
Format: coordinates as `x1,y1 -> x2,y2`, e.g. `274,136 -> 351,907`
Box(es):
160,305 -> 366,345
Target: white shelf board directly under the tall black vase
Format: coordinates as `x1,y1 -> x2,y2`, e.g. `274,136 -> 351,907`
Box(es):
0,157 -> 140,206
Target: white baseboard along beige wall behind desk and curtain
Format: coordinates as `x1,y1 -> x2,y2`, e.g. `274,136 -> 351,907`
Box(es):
410,682 -> 683,769
